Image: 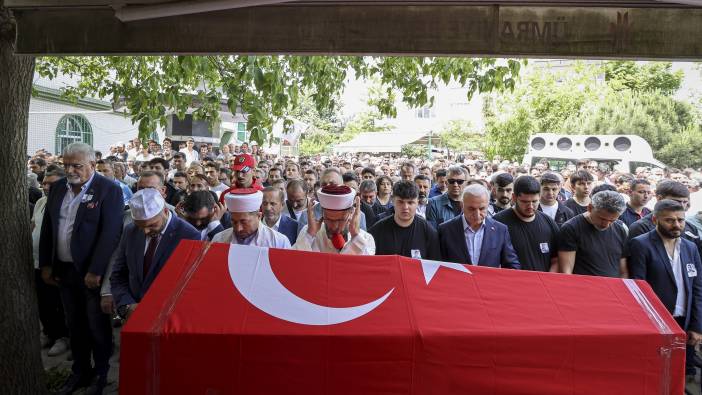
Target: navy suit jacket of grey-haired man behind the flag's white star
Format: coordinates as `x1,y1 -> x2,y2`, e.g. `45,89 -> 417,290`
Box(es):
439,215 -> 520,269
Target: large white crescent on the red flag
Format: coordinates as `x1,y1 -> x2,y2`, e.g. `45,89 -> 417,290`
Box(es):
229,244 -> 395,325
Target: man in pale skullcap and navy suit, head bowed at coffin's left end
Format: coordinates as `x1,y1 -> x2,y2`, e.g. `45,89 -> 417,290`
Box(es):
111,188 -> 201,318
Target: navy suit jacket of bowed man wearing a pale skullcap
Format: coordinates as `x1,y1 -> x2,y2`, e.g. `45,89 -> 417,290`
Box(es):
110,214 -> 200,306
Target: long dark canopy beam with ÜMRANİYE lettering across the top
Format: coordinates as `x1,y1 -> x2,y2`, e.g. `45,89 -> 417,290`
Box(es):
5,0 -> 702,59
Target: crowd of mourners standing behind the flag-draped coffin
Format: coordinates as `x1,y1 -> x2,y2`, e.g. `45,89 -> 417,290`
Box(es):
27,135 -> 702,394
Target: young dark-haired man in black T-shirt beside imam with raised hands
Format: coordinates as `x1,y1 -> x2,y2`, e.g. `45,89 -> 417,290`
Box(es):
368,181 -> 441,260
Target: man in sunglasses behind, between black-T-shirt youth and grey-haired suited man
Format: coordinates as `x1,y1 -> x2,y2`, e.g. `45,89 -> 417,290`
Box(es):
426,166 -> 468,229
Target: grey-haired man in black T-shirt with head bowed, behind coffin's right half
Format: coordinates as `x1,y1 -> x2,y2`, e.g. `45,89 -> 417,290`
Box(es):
558,191 -> 628,278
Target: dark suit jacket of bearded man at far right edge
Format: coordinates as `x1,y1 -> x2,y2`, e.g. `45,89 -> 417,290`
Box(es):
628,229 -> 702,333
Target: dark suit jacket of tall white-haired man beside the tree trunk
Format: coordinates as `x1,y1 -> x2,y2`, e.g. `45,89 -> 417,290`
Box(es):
39,173 -> 124,277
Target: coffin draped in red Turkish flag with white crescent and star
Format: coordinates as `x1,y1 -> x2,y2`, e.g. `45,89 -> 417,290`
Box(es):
120,241 -> 685,395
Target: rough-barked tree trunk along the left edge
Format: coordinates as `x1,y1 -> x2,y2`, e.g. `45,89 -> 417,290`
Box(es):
0,0 -> 46,395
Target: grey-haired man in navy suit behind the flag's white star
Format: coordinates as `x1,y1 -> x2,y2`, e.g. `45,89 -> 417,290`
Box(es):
439,184 -> 520,269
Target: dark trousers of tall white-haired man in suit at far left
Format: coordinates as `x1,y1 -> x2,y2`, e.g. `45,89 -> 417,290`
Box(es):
59,262 -> 112,376
